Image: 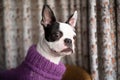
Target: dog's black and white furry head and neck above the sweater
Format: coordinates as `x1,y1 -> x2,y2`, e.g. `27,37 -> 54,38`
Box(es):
37,5 -> 77,64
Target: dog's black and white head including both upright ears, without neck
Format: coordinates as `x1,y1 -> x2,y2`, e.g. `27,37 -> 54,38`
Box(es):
41,5 -> 77,56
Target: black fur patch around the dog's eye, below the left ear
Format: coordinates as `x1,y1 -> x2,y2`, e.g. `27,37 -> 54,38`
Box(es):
44,22 -> 63,42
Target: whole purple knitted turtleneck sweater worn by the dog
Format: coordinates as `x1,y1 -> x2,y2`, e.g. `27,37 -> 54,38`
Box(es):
0,46 -> 65,80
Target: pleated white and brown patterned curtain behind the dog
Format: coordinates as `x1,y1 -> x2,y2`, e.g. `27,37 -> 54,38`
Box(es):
0,0 -> 120,80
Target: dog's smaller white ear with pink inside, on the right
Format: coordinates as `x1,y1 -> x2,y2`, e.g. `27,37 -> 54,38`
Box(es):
66,11 -> 77,27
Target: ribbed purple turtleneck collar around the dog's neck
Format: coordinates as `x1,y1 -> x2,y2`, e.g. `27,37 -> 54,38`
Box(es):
24,45 -> 65,78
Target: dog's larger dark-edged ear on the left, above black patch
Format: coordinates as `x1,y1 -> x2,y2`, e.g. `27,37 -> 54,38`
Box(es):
41,5 -> 56,27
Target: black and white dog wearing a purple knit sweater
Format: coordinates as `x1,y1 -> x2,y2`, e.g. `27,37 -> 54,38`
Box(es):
0,5 -> 77,80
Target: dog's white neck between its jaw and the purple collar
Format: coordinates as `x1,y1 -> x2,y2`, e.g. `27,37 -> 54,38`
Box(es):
37,38 -> 62,64
